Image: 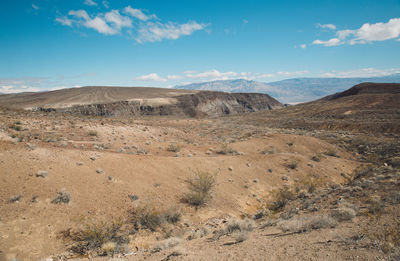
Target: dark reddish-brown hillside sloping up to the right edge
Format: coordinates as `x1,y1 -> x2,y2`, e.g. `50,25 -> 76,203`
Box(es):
234,83 -> 400,134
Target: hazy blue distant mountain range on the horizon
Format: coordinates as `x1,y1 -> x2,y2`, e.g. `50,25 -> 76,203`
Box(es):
175,74 -> 400,103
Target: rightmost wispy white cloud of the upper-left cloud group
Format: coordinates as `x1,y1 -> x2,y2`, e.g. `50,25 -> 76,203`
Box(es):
136,21 -> 207,43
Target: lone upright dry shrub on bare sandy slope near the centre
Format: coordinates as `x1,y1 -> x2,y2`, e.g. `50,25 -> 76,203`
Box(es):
182,171 -> 215,207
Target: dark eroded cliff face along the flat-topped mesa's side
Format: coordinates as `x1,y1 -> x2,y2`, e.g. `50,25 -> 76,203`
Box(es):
47,91 -> 283,117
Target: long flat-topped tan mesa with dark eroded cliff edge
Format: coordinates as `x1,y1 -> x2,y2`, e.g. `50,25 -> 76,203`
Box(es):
0,87 -> 283,117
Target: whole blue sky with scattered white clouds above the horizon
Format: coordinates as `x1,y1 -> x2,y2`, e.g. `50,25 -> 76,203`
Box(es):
0,0 -> 400,92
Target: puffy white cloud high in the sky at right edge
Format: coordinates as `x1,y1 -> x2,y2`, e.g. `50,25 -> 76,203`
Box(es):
313,18 -> 400,46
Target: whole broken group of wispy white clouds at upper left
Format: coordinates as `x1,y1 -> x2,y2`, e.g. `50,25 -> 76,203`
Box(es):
55,4 -> 208,43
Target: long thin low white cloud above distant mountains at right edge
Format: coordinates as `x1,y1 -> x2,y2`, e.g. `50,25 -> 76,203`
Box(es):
321,68 -> 400,78
